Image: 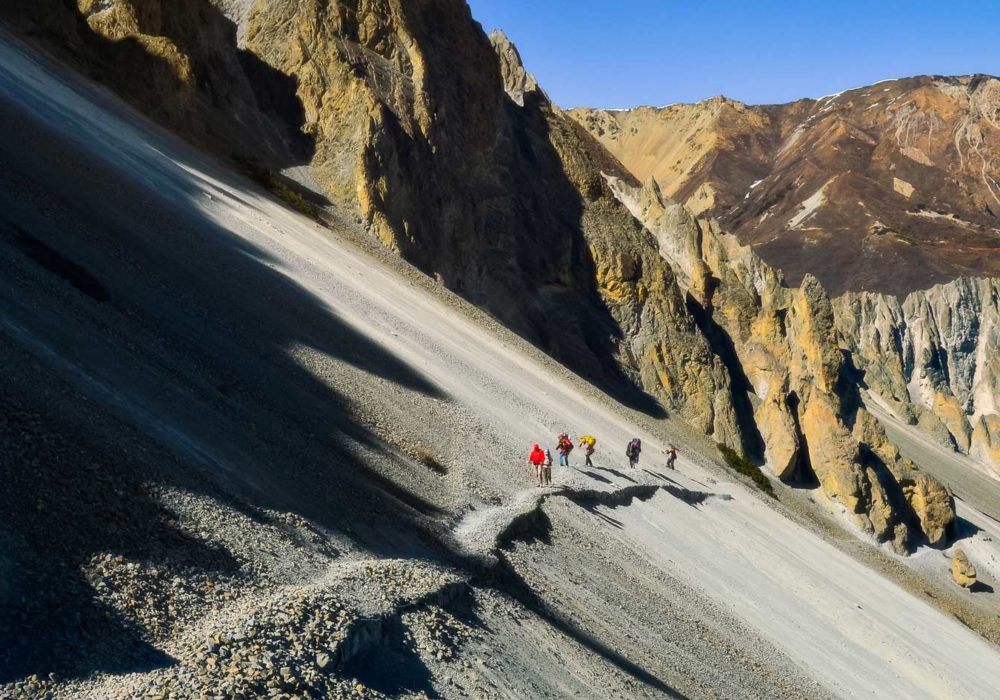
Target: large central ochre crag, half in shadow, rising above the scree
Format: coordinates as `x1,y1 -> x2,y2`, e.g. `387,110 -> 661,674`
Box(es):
236,0 -> 752,443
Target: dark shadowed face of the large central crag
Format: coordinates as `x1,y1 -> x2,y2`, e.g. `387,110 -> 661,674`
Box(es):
356,27 -> 666,418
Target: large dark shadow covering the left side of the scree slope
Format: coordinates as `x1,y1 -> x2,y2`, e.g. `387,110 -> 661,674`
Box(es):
0,49 -> 447,682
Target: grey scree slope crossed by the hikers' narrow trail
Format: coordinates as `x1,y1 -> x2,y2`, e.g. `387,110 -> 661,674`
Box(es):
0,26 -> 1000,700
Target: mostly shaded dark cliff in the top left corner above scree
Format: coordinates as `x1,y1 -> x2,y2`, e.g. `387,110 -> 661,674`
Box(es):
0,0 -> 312,170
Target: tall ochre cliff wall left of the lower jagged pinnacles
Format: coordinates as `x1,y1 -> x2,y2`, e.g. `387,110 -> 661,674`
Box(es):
0,0 -> 741,444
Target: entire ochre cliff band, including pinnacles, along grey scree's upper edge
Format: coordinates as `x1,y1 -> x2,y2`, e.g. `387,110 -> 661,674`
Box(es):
3,0 -> 954,551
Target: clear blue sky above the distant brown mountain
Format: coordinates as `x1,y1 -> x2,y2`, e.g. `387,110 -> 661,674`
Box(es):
469,0 -> 1000,107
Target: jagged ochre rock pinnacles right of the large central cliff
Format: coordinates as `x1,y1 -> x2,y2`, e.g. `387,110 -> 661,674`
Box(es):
609,178 -> 955,552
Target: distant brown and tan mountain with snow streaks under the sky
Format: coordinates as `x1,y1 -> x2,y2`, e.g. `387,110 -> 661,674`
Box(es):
569,76 -> 1000,294
